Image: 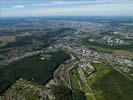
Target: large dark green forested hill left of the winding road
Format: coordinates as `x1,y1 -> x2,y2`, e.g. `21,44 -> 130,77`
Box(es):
0,51 -> 70,93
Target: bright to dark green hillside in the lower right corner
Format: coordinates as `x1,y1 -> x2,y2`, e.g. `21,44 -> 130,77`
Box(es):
89,64 -> 133,100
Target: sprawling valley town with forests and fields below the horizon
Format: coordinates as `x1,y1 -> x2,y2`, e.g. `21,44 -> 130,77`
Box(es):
0,0 -> 133,100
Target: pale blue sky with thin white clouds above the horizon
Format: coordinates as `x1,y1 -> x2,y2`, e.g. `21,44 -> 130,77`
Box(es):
0,0 -> 133,17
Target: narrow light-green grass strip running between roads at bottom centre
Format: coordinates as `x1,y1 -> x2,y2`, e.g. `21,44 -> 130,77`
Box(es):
70,68 -> 95,100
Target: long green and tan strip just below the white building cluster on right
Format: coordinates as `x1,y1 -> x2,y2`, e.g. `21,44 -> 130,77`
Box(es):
81,39 -> 133,56
